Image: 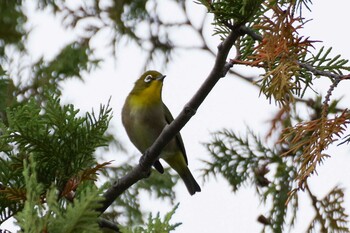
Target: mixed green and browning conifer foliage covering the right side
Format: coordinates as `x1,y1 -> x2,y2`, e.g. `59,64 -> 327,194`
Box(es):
202,0 -> 350,232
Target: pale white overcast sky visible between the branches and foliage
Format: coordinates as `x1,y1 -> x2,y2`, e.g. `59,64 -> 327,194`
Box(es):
4,0 -> 350,233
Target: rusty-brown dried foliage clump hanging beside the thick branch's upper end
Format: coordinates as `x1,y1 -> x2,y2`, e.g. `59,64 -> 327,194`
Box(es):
246,6 -> 314,105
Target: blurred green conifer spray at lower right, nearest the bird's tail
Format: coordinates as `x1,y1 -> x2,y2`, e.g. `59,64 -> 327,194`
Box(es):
202,129 -> 298,232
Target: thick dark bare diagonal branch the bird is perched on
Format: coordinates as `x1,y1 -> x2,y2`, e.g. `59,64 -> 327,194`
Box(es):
98,24 -> 241,213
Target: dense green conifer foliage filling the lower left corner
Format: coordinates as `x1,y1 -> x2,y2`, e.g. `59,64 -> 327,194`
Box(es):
0,96 -> 111,232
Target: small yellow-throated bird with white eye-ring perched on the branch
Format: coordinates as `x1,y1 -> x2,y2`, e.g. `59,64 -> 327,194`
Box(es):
122,70 -> 201,195
